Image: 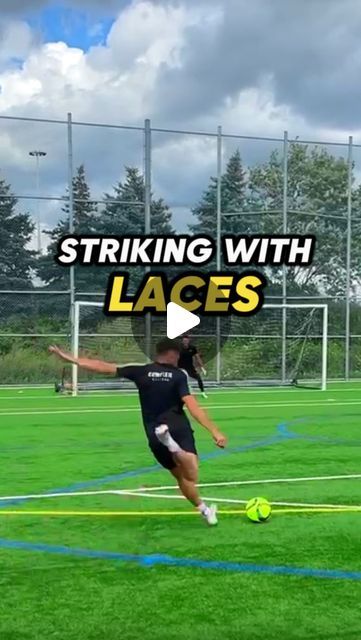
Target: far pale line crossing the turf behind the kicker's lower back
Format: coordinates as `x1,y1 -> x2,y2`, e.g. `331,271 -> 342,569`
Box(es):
0,398 -> 361,416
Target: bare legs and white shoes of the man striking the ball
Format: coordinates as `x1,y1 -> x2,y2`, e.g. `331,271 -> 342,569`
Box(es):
156,425 -> 218,525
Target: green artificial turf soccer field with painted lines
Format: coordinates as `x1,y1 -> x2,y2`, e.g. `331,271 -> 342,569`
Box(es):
0,383 -> 361,640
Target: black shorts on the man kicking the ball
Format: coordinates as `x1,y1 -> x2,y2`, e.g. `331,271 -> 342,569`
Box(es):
148,417 -> 198,471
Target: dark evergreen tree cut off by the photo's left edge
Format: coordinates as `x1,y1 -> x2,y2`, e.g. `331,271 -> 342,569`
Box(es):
0,179 -> 36,289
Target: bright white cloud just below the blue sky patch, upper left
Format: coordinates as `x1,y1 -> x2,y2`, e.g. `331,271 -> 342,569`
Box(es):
0,1 -> 201,123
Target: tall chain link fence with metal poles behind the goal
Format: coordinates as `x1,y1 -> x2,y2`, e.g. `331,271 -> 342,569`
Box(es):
0,114 -> 361,384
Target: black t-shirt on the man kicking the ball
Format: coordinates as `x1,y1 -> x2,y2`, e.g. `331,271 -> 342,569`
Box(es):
117,362 -> 190,436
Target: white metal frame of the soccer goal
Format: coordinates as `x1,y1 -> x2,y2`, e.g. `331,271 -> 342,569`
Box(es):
72,300 -> 328,396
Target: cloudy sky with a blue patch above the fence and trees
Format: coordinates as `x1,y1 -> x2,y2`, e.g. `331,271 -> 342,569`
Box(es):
0,0 -> 361,236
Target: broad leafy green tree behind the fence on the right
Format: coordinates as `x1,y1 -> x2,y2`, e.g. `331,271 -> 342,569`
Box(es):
248,144 -> 354,295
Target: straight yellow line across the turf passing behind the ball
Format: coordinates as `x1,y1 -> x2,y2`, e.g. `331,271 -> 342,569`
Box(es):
0,507 -> 361,518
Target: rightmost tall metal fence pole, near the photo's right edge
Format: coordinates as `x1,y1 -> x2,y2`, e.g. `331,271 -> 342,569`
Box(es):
345,136 -> 353,380
